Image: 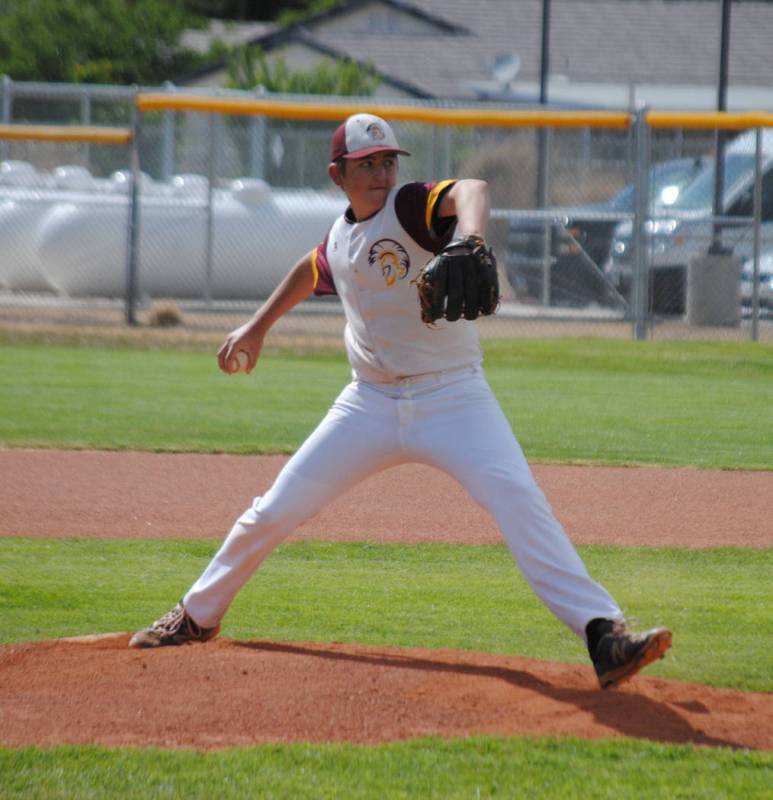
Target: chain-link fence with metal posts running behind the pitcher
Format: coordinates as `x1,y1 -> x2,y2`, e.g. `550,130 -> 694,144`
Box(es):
0,79 -> 773,341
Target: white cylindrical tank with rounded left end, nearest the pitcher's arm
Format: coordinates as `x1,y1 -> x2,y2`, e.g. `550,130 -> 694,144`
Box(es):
38,176 -> 346,299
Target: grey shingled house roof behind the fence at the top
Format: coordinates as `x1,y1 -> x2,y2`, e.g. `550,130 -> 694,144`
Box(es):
178,0 -> 773,99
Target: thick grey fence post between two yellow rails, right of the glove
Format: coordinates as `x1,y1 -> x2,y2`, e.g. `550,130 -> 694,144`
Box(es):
631,108 -> 650,340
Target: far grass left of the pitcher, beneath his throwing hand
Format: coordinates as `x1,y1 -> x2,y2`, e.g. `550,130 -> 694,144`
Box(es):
0,345 -> 347,453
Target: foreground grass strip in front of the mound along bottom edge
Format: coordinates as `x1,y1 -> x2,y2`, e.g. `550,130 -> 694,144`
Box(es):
0,737 -> 773,800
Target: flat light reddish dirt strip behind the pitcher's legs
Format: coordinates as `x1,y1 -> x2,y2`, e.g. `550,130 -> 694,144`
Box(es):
0,449 -> 773,547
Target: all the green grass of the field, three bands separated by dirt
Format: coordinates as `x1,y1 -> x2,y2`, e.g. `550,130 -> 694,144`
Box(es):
0,340 -> 773,798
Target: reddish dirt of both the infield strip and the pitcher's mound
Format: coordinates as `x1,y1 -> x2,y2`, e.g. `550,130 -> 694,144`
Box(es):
0,450 -> 773,750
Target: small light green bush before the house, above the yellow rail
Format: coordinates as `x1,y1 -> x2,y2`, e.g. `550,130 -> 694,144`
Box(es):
227,47 -> 379,96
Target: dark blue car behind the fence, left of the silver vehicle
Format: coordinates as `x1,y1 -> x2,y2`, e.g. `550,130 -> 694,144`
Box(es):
505,158 -> 707,306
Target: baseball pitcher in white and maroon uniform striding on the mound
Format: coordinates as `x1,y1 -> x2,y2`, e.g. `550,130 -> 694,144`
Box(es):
130,113 -> 671,688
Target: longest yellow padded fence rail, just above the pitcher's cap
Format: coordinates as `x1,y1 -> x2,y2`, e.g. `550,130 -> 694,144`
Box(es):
137,92 -> 631,128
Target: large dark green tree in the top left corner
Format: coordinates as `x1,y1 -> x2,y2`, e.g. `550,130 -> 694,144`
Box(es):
0,0 -> 206,84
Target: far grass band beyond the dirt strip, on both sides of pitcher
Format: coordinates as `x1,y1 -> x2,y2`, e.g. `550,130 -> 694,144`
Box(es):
0,340 -> 773,469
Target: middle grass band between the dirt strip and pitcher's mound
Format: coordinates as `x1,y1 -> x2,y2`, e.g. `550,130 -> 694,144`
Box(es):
0,538 -> 773,691
